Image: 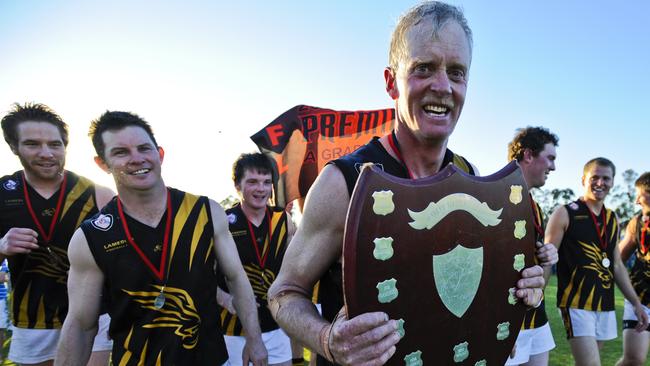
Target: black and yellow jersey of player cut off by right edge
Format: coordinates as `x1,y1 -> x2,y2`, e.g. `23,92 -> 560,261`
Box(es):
630,214 -> 650,307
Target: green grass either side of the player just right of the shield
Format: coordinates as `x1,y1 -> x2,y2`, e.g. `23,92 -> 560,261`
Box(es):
545,276 -> 623,366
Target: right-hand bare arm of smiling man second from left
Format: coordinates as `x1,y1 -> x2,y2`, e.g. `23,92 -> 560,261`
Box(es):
210,200 -> 268,366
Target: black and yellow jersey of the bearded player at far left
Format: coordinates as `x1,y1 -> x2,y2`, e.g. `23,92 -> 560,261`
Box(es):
0,171 -> 97,329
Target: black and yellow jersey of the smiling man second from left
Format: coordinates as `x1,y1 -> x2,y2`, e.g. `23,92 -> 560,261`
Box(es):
81,188 -> 228,365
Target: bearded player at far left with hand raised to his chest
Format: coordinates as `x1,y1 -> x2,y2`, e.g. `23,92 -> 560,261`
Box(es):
0,104 -> 113,365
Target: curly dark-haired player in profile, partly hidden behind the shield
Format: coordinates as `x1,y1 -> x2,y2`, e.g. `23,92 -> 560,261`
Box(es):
506,127 -> 558,366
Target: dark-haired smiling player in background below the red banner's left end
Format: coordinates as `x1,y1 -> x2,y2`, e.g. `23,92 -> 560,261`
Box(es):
220,153 -> 295,366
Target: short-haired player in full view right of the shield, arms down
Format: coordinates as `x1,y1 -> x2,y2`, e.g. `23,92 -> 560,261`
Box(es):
546,158 -> 648,366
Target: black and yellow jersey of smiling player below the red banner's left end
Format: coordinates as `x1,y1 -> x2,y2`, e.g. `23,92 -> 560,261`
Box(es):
221,204 -> 288,336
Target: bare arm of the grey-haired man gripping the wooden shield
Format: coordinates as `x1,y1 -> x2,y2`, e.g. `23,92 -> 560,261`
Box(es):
269,165 -> 399,365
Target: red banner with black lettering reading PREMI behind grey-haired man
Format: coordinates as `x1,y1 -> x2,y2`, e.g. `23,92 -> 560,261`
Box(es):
251,105 -> 395,206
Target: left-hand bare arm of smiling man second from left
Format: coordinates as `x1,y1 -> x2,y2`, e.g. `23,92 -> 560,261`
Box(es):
55,229 -> 104,365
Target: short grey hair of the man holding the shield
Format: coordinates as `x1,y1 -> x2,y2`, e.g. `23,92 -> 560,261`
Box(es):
388,1 -> 473,71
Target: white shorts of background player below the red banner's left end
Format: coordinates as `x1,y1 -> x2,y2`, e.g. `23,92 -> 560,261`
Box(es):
223,328 -> 291,366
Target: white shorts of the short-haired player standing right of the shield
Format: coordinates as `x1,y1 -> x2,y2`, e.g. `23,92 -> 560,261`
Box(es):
560,308 -> 617,341
